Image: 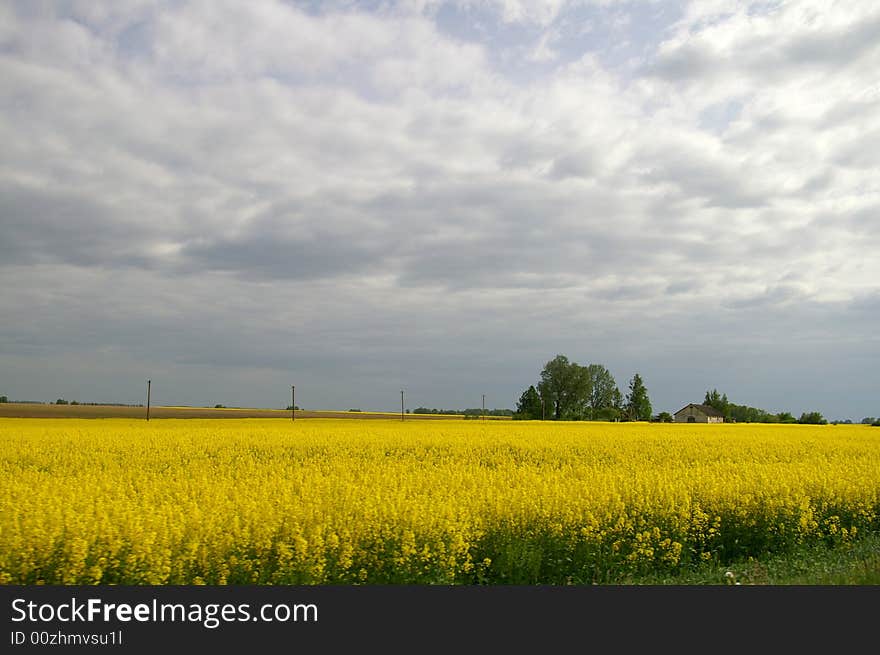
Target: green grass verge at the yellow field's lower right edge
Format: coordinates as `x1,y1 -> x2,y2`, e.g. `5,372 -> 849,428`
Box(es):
612,534 -> 880,585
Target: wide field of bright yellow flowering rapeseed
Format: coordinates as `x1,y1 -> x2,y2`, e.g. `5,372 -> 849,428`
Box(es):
0,418 -> 880,584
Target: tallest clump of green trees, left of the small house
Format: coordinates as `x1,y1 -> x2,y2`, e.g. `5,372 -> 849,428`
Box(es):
514,355 -> 652,421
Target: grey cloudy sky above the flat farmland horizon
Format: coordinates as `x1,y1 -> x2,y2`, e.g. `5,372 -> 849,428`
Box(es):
0,0 -> 880,420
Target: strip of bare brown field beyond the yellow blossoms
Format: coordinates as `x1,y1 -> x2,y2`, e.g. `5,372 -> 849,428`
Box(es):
0,403 -> 502,420
